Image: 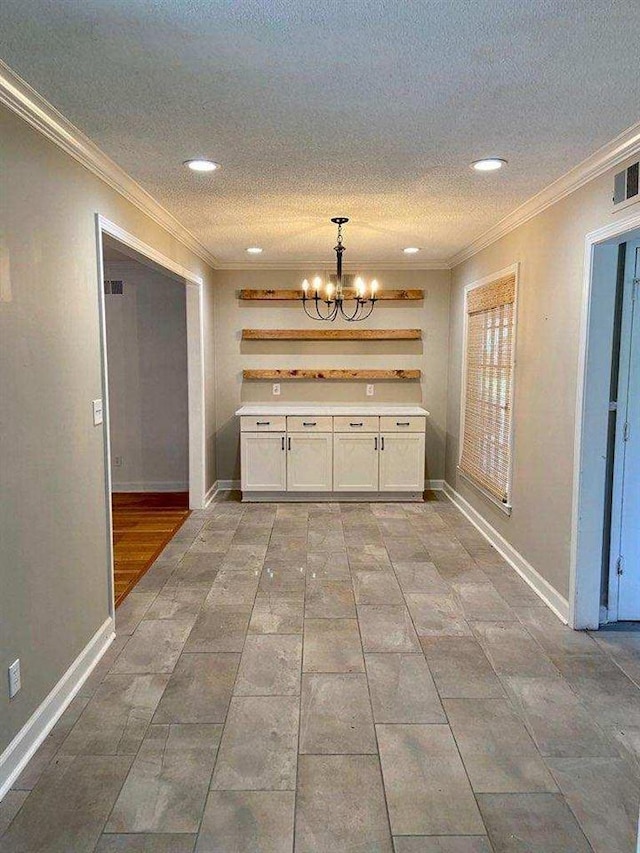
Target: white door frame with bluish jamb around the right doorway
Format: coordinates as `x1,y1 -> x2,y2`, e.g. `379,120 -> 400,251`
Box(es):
569,210 -> 640,629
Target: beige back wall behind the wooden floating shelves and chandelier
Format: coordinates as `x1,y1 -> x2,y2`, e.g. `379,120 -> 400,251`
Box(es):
215,270 -> 450,480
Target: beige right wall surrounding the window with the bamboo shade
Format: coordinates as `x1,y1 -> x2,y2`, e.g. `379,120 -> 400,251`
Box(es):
446,173 -> 615,598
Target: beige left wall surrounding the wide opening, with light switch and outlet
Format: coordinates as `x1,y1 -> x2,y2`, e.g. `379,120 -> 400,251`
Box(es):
0,109 -> 216,752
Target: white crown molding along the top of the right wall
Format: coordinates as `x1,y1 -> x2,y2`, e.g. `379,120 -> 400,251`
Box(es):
449,122 -> 640,269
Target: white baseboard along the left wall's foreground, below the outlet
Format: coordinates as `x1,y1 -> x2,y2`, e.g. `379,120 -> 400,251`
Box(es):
0,617 -> 115,800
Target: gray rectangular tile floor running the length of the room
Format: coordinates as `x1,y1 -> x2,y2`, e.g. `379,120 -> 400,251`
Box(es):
0,497 -> 640,853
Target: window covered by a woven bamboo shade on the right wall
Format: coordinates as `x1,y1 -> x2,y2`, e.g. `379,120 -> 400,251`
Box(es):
460,269 -> 516,509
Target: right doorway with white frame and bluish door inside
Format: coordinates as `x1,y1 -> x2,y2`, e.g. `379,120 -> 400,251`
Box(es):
570,212 -> 640,629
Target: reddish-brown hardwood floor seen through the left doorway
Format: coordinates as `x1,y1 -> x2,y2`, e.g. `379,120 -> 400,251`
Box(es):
111,492 -> 189,607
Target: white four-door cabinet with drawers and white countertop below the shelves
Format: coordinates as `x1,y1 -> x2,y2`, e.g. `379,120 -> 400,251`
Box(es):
237,405 -> 428,501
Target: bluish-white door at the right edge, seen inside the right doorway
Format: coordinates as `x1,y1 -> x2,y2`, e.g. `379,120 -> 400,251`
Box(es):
609,243 -> 640,620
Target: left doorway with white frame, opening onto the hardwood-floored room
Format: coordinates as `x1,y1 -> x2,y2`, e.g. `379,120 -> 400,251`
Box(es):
97,216 -> 205,613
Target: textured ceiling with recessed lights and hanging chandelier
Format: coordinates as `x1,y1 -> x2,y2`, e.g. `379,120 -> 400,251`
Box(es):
0,0 -> 640,264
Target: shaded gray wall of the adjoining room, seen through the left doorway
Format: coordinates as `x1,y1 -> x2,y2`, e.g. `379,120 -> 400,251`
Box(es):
105,261 -> 189,492
